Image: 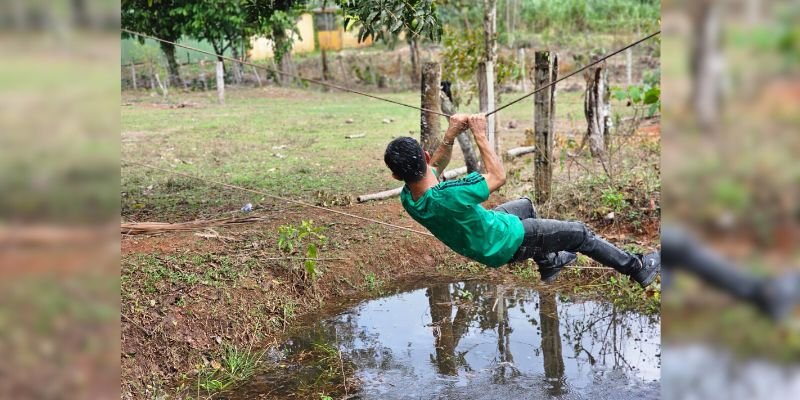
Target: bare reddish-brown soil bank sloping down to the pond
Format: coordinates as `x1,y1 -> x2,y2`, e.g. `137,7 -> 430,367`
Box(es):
121,190 -> 658,398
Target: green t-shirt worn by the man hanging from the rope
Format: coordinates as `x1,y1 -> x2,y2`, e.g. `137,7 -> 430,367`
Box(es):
400,172 -> 525,267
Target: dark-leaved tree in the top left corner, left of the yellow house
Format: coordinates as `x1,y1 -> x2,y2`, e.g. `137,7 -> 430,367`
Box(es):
121,0 -> 189,86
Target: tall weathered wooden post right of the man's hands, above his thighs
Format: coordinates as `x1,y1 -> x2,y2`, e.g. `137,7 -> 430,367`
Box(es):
533,51 -> 558,203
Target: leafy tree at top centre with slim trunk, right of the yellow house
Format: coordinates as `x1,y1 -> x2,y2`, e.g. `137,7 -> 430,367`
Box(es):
339,0 -> 442,82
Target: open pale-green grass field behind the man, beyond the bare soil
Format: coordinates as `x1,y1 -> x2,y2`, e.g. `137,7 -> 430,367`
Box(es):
121,88 -> 583,220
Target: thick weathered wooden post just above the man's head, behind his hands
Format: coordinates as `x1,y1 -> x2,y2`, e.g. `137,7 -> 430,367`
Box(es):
420,62 -> 442,154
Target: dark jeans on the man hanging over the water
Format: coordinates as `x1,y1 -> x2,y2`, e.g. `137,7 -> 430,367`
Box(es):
494,197 -> 639,275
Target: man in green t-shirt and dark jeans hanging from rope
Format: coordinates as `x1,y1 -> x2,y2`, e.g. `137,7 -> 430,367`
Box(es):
383,114 -> 661,287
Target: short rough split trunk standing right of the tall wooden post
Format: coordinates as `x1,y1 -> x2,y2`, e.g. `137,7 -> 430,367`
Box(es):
583,63 -> 610,158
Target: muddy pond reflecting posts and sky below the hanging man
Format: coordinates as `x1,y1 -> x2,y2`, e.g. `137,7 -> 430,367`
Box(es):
228,282 -> 661,400
